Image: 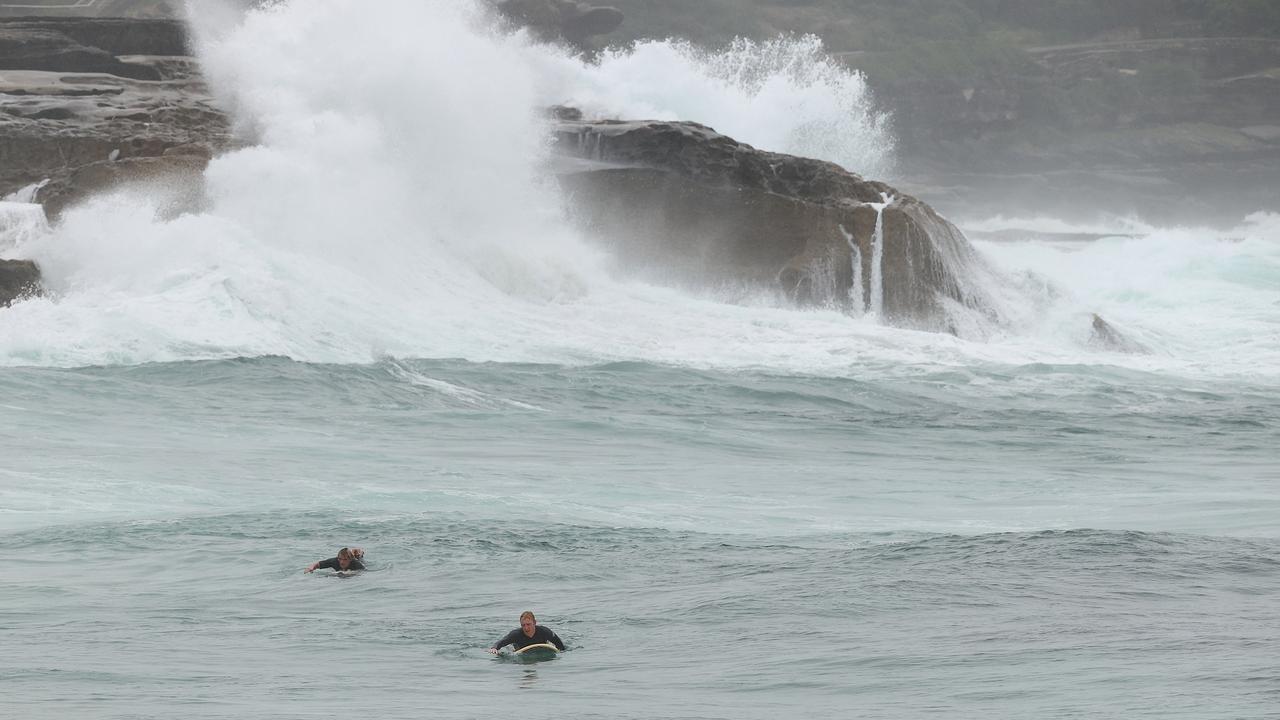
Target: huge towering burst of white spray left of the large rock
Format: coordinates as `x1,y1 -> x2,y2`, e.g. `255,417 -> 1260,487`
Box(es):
0,0 -> 602,364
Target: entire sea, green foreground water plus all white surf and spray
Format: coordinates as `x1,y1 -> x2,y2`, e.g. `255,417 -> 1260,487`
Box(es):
0,0 -> 1280,720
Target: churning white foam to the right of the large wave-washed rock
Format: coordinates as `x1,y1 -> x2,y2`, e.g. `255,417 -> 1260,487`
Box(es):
974,207 -> 1280,363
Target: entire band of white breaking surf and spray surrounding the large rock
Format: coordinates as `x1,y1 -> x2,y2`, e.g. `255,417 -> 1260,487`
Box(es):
0,0 -> 1280,375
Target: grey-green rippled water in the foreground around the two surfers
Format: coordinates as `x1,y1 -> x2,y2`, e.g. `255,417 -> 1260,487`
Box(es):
0,357 -> 1280,719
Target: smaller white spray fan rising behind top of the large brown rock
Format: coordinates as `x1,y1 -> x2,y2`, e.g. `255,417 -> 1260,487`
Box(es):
544,35 -> 895,178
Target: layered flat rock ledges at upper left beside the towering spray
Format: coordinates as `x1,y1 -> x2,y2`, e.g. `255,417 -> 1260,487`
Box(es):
0,18 -> 230,218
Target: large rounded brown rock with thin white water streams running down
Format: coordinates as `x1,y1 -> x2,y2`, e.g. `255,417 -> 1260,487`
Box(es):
556,117 -> 998,333
